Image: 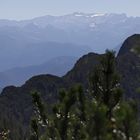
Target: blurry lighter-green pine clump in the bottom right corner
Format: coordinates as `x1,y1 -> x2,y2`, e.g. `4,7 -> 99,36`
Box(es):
116,101 -> 140,140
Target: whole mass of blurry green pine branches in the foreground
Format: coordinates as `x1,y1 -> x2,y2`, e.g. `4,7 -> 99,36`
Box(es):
31,51 -> 139,140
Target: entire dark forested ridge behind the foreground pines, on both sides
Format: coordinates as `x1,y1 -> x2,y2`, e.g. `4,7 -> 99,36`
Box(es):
0,35 -> 140,140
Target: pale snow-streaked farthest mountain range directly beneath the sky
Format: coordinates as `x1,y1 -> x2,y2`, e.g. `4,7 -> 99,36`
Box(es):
0,12 -> 140,52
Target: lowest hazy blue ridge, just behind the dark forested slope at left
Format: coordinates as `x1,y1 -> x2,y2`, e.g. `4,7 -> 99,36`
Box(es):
0,56 -> 78,88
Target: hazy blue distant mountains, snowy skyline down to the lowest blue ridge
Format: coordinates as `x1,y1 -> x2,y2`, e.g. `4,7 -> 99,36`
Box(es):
0,12 -> 140,78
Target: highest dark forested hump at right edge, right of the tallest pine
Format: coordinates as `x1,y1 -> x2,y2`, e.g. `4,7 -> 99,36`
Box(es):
117,34 -> 140,98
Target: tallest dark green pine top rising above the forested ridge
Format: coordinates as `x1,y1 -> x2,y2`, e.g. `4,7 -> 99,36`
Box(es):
90,51 -> 122,118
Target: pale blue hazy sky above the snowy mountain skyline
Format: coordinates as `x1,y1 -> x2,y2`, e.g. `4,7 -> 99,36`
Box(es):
0,0 -> 140,20
